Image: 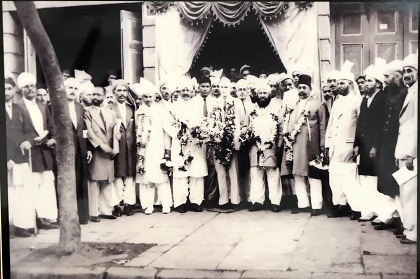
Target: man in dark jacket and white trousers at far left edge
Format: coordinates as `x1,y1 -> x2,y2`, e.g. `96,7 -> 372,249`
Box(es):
4,77 -> 35,237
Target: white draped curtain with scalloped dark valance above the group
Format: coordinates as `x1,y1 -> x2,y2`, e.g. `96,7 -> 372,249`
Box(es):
151,1 -> 320,88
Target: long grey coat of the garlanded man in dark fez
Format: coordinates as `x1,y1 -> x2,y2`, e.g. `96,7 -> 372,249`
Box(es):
280,97 -> 325,176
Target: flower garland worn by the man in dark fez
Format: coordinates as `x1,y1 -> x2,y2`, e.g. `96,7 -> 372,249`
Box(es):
283,102 -> 310,163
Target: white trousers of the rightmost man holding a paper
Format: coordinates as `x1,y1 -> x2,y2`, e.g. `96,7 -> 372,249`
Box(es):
398,160 -> 417,241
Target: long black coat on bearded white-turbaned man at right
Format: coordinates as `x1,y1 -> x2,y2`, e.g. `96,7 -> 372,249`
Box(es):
354,90 -> 385,176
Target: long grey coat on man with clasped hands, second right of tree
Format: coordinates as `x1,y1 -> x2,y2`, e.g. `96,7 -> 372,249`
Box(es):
85,106 -> 117,183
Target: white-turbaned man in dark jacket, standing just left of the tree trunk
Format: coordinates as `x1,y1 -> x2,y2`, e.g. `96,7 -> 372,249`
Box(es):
17,73 -> 58,232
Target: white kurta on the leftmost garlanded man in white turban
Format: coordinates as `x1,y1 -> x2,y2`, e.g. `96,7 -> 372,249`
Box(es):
135,103 -> 171,184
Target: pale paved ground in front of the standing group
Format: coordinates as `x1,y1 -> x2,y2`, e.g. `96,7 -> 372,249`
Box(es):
10,210 -> 417,279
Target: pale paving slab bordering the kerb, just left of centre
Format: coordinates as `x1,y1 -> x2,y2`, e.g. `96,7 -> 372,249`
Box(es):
149,245 -> 233,270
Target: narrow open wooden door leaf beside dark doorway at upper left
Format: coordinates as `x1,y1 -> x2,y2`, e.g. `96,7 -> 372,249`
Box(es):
120,10 -> 143,84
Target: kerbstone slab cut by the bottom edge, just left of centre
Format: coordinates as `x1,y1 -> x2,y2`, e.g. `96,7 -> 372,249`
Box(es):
157,270 -> 241,279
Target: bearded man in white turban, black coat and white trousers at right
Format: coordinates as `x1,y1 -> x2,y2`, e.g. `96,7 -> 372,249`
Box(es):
354,65 -> 385,225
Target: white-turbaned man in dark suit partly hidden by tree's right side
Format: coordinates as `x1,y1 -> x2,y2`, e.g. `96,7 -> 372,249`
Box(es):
64,78 -> 92,224
